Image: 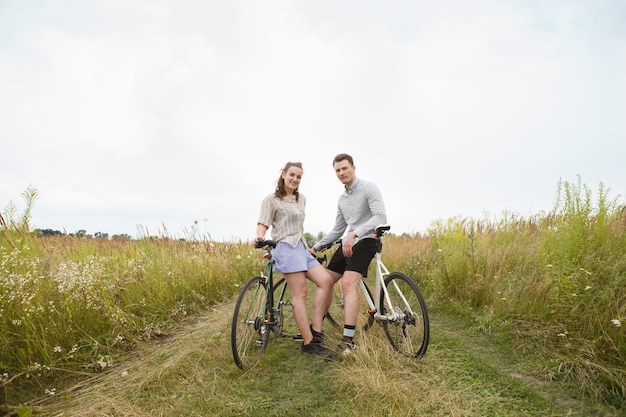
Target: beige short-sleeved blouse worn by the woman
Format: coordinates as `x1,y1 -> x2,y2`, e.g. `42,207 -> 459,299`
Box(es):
259,194 -> 307,248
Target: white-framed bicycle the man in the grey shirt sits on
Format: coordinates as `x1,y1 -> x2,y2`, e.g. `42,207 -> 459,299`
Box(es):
276,225 -> 430,359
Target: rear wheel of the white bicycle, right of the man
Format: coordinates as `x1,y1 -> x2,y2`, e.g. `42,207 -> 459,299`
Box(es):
380,272 -> 430,359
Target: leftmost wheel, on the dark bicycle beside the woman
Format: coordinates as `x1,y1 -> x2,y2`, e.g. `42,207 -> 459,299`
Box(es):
230,276 -> 269,369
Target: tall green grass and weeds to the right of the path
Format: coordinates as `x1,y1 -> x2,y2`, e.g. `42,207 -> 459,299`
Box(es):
386,178 -> 626,404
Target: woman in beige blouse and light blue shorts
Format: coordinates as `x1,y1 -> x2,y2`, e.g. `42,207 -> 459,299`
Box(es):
253,162 -> 334,356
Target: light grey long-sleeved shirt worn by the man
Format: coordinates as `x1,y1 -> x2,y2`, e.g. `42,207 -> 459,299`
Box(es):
315,178 -> 387,250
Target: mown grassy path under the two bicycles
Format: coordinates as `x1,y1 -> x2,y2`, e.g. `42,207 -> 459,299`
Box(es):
26,304 -> 618,417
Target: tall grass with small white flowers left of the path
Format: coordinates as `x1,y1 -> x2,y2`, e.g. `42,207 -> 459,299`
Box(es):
0,200 -> 261,403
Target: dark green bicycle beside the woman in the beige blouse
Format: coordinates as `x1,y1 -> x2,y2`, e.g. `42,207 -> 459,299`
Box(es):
231,240 -> 293,369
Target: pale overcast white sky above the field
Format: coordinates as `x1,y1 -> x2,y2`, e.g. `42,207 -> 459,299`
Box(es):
0,0 -> 626,242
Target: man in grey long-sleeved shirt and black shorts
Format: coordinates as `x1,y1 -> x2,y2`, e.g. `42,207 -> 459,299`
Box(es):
310,153 -> 387,353
